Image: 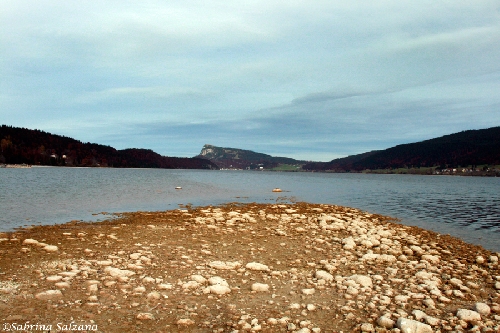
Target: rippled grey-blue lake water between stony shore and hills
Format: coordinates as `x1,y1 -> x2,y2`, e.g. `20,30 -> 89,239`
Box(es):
0,167 -> 500,251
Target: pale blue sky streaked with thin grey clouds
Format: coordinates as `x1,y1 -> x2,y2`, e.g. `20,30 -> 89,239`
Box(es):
0,0 -> 500,161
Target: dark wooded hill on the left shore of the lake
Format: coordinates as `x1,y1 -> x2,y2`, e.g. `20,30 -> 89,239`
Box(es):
0,125 -> 218,169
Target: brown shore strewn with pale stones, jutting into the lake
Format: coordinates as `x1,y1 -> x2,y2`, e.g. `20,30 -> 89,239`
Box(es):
0,203 -> 500,333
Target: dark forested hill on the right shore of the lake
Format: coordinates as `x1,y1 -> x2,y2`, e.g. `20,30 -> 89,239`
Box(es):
303,127 -> 500,172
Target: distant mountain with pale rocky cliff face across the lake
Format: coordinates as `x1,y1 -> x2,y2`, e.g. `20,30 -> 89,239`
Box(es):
195,145 -> 306,169
